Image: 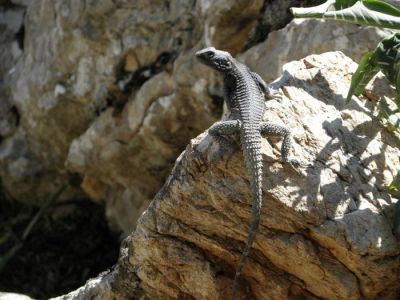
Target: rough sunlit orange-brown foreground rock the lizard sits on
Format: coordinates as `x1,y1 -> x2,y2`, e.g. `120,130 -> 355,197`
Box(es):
54,52 -> 400,299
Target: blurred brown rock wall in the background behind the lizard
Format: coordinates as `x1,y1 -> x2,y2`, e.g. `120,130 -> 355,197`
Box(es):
0,0 -> 396,234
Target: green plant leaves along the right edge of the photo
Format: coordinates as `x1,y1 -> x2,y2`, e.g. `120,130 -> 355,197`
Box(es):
290,0 -> 400,237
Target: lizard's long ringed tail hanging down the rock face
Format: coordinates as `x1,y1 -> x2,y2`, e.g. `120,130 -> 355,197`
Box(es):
232,130 -> 262,300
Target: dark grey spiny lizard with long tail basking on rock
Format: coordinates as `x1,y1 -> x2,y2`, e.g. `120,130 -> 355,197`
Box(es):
195,47 -> 299,299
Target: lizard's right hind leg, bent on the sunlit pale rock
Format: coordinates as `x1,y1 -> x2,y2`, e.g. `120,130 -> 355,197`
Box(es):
260,122 -> 300,170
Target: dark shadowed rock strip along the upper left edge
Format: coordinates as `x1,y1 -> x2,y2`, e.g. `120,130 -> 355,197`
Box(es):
0,1 -> 55,201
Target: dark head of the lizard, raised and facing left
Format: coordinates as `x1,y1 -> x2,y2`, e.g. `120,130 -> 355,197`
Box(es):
196,47 -> 232,72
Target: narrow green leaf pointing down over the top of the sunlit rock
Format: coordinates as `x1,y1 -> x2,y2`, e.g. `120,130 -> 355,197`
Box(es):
346,52 -> 379,102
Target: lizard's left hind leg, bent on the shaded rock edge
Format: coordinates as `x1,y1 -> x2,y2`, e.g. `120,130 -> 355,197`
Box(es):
208,120 -> 242,167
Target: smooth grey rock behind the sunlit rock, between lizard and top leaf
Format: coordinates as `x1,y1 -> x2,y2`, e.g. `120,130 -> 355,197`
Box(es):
239,19 -> 393,82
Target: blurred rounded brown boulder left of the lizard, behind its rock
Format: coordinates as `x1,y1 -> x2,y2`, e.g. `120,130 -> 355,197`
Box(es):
67,72 -> 215,234
